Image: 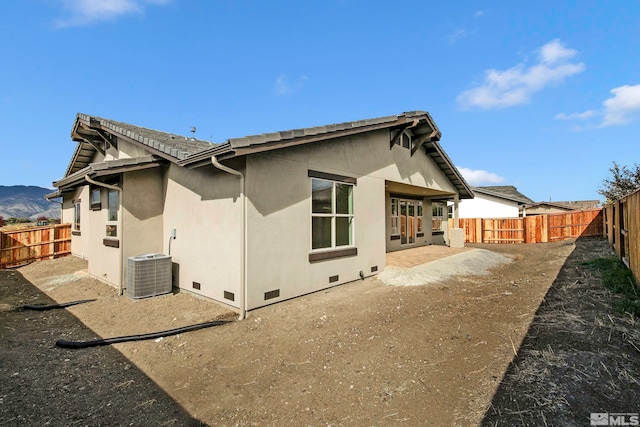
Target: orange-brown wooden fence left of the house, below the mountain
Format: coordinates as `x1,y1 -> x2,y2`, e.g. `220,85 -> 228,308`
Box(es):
0,224 -> 71,268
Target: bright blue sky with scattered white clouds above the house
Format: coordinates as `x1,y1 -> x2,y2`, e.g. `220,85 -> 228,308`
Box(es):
0,0 -> 640,201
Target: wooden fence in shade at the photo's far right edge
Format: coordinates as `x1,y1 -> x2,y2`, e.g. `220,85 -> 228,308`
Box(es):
604,189 -> 640,284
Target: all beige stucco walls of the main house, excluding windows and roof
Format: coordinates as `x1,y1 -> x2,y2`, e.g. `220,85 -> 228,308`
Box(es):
63,126 -> 462,309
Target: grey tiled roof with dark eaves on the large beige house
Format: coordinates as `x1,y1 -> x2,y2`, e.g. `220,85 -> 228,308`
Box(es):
54,111 -> 473,199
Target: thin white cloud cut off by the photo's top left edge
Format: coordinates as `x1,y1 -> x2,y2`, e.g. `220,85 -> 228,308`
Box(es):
56,0 -> 171,28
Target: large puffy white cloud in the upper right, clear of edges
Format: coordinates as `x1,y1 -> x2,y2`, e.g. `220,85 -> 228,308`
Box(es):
458,40 -> 585,109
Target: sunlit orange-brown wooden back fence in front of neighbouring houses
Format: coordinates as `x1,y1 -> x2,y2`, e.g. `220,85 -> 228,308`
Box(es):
449,209 -> 604,243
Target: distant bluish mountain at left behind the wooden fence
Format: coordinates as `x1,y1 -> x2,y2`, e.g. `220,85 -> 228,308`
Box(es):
0,185 -> 60,219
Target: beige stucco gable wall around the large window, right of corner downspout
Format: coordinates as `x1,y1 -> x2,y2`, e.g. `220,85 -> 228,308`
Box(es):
246,131 -> 455,309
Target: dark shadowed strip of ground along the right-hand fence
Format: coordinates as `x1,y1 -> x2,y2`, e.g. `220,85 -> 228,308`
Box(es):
482,237 -> 640,426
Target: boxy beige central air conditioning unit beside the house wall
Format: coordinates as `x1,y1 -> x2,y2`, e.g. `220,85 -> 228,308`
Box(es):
127,254 -> 172,298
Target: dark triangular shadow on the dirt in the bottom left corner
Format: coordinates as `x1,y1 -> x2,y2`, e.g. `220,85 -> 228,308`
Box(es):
0,270 -> 205,426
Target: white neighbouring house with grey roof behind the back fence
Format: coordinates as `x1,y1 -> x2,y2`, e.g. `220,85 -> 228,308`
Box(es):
458,185 -> 533,218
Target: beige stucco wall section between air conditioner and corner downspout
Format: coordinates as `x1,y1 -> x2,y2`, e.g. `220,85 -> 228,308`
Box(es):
162,165 -> 242,307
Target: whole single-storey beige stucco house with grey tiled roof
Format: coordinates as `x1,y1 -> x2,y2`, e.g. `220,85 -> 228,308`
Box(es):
48,111 -> 473,316
